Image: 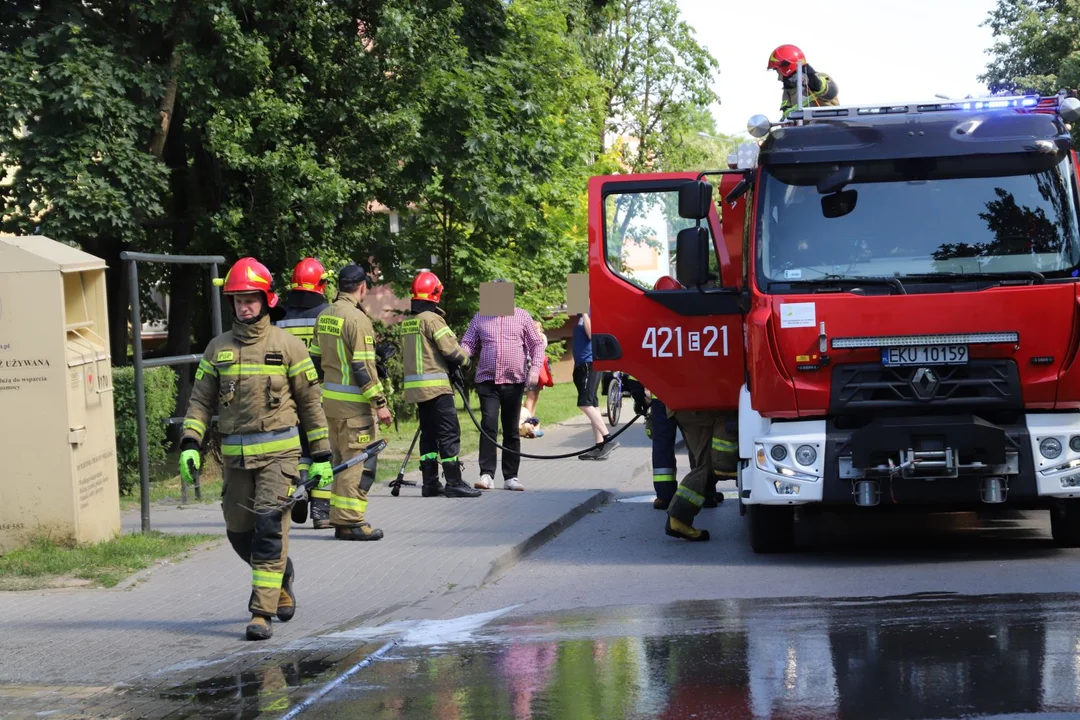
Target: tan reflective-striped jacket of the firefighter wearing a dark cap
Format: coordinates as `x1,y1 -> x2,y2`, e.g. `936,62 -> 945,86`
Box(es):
315,293 -> 387,420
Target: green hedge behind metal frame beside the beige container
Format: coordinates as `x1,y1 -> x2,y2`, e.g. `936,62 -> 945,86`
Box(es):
112,367 -> 176,495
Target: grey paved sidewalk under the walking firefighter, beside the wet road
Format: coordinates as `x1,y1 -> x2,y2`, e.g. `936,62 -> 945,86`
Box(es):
0,403 -> 651,718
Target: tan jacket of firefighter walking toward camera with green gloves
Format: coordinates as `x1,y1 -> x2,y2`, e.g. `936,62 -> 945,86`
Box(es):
184,315 -> 330,470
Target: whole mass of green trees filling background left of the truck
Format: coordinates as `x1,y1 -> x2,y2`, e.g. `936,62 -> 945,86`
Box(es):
0,0 -> 724,357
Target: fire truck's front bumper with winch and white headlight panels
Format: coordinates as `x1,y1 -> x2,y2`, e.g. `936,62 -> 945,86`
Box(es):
739,412 -> 1080,510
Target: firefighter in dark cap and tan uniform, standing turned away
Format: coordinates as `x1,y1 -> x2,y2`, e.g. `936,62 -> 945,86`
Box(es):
315,264 -> 393,540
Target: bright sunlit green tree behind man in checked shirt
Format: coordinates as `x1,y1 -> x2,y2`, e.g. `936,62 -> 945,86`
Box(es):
384,0 -> 595,325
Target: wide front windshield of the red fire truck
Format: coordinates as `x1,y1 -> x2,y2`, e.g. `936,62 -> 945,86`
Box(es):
756,152 -> 1080,291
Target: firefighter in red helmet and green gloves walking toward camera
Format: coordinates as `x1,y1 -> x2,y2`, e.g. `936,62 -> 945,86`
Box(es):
180,258 -> 333,640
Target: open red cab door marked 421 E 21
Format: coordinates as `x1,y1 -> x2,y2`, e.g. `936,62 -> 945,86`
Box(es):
589,173 -> 745,410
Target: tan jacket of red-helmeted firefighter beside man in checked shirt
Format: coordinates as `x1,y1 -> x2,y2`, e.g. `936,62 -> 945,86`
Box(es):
401,310 -> 469,403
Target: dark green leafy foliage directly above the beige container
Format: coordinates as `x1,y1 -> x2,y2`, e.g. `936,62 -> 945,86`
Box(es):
0,15 -> 166,245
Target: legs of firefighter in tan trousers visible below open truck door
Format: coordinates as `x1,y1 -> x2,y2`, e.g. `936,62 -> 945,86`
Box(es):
664,410 -> 739,541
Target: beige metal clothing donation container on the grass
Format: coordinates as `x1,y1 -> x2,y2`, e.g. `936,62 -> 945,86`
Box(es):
0,235 -> 120,553
